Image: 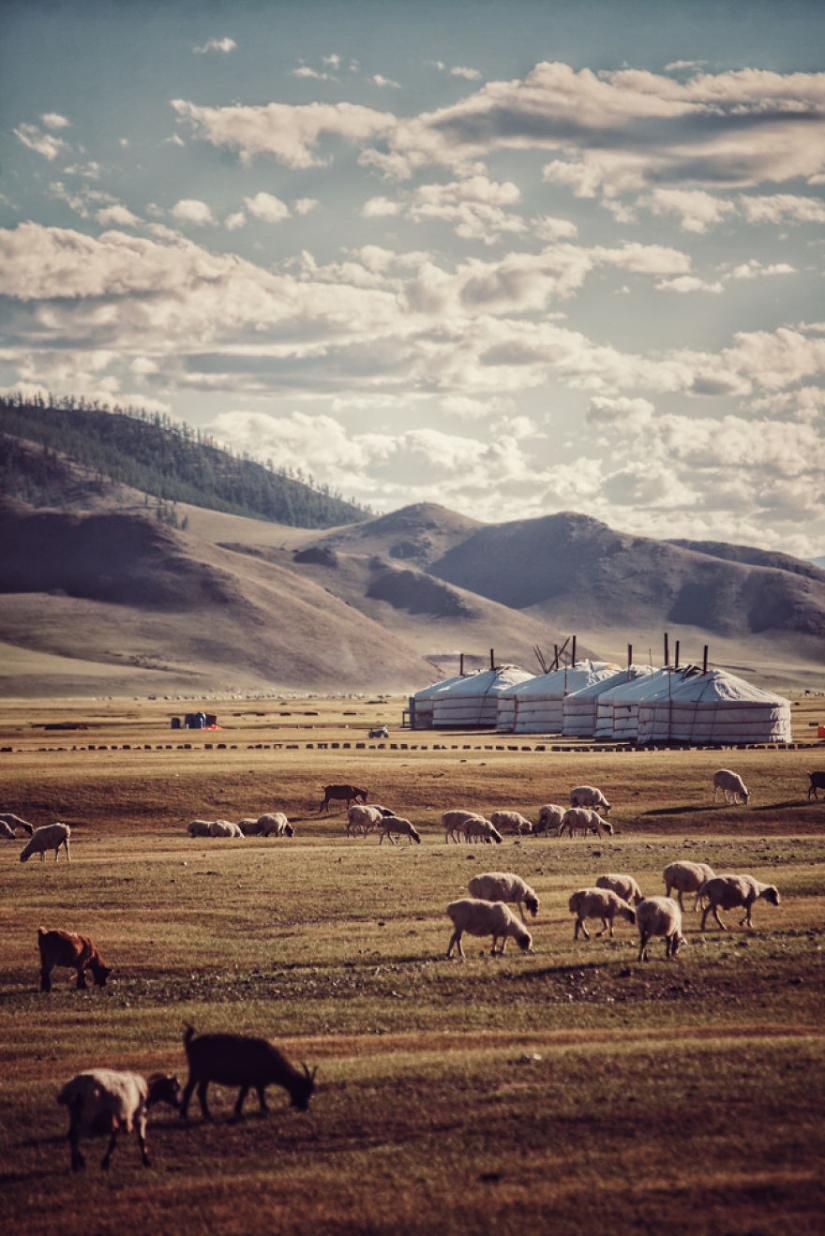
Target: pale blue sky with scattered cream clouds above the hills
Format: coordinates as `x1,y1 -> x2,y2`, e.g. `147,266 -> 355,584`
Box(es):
0,0 -> 825,556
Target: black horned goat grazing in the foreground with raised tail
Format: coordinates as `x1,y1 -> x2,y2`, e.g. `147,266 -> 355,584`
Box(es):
181,1025 -> 318,1120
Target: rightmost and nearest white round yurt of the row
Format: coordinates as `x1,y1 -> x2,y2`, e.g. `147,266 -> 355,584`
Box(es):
637,670 -> 790,745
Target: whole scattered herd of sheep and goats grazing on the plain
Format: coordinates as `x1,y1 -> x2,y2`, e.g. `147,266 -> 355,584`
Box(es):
0,769 -> 825,1170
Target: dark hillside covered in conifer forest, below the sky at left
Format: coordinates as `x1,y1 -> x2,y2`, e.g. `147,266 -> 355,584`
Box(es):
0,398 -> 370,528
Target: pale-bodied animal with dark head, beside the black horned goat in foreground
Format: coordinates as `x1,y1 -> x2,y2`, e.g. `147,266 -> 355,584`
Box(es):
57,1069 -> 181,1172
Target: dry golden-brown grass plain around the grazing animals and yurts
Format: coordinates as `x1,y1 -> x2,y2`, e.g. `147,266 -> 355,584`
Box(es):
0,697 -> 825,1236
